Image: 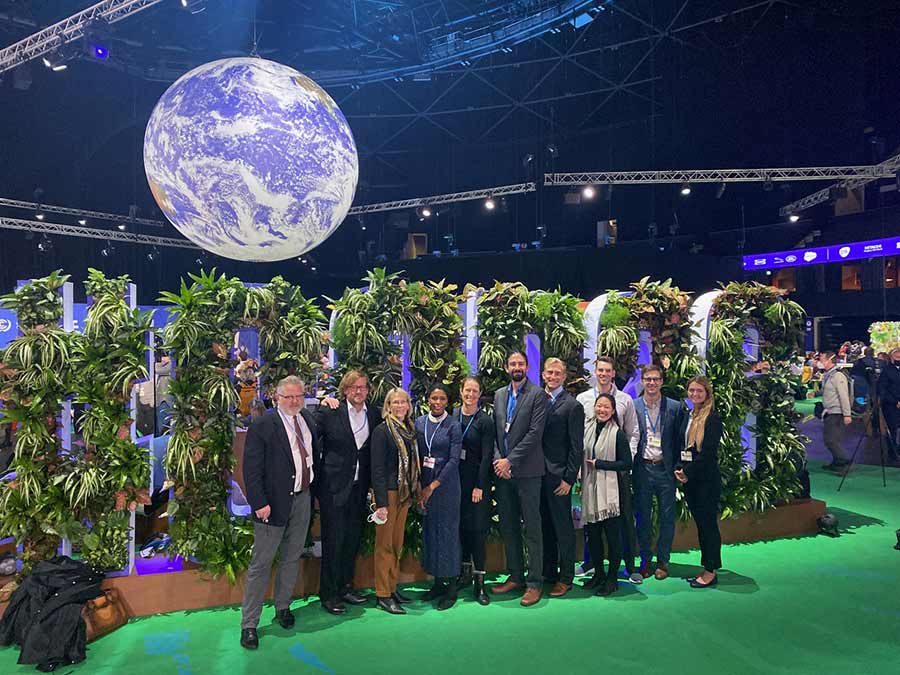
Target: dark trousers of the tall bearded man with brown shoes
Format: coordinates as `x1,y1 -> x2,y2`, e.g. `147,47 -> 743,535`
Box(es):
497,477 -> 544,588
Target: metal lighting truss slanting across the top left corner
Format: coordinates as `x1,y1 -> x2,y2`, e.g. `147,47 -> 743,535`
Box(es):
0,0 -> 162,73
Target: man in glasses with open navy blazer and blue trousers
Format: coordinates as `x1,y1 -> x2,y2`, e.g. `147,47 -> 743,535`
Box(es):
634,365 -> 680,579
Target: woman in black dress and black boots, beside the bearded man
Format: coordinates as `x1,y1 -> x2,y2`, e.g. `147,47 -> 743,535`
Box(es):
453,377 -> 495,605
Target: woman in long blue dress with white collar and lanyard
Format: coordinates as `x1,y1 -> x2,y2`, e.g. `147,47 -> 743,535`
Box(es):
416,384 -> 462,610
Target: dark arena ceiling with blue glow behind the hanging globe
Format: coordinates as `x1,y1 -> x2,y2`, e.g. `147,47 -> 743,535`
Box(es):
0,0 -> 900,298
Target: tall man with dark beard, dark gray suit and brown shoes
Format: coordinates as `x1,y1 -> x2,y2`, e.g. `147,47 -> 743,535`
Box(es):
491,351 -> 547,607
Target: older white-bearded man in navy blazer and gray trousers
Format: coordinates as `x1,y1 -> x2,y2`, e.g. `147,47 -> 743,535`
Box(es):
241,375 -> 321,649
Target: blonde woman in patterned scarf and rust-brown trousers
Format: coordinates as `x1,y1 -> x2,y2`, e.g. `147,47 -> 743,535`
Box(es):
371,388 -> 420,614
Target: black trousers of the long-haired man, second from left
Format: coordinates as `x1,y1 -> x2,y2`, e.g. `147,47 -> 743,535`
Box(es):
319,483 -> 366,602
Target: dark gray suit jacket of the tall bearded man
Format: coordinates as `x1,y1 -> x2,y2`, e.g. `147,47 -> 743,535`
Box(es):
494,378 -> 547,478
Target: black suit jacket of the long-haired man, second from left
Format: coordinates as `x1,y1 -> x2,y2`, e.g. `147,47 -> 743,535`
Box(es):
316,401 -> 381,505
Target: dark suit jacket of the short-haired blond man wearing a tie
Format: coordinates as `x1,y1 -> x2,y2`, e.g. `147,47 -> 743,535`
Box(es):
542,390 -> 584,485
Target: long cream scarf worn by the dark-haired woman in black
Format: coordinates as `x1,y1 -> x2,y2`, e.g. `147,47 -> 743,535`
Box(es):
581,419 -> 621,523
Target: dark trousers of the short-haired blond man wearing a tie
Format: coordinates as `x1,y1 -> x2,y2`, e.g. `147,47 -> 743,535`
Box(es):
541,475 -> 575,586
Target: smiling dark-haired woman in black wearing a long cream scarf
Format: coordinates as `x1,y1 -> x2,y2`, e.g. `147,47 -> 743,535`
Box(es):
581,394 -> 632,596
